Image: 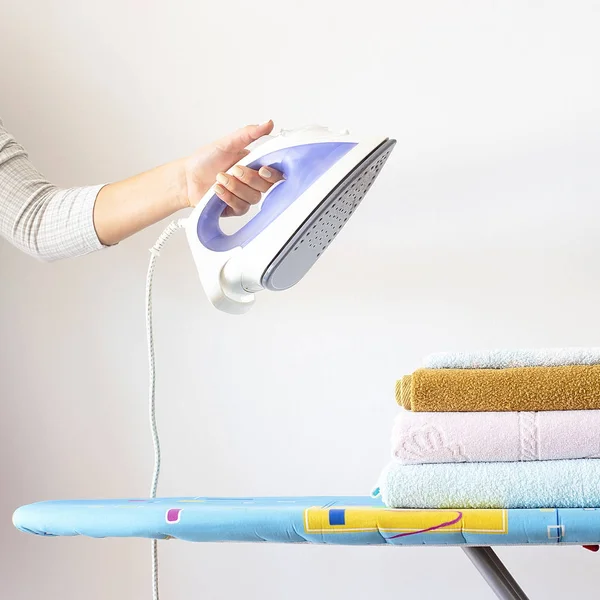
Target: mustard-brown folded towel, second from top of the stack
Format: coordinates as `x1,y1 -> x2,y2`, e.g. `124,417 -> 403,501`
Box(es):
396,365 -> 600,412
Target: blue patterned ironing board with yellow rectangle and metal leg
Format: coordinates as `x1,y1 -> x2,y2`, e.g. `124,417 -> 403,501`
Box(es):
13,496 -> 600,600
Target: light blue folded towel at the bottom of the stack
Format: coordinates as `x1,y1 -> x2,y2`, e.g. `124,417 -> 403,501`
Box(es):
375,459 -> 600,508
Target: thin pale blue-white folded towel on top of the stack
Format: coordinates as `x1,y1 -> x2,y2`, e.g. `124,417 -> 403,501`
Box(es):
423,348 -> 600,369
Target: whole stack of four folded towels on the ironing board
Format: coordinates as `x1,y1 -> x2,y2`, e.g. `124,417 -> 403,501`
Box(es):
375,348 -> 600,508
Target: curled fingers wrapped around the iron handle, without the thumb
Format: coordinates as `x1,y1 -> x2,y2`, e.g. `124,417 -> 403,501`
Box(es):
215,165 -> 283,216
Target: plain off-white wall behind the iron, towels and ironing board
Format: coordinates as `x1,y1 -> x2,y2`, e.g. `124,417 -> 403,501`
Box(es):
0,0 -> 600,600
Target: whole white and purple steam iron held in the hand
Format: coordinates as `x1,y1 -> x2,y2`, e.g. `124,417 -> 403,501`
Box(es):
185,127 -> 396,314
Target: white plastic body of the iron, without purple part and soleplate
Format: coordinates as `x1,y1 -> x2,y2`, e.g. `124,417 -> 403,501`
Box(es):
186,127 -> 394,314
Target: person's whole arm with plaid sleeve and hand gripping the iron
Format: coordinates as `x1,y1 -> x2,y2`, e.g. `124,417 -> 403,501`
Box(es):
0,121 -> 281,260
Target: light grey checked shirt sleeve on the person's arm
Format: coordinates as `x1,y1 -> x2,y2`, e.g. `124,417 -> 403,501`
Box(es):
0,120 -> 104,261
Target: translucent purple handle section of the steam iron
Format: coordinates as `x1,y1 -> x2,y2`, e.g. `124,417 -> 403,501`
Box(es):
197,142 -> 356,252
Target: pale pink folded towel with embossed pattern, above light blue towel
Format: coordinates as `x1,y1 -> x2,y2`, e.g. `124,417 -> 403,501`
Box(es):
392,409 -> 600,464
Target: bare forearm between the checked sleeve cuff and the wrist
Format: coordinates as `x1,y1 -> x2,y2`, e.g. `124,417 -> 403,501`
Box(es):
94,161 -> 188,246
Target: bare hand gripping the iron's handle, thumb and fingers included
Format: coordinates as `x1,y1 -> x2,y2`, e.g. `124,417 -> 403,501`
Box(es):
185,121 -> 283,217
